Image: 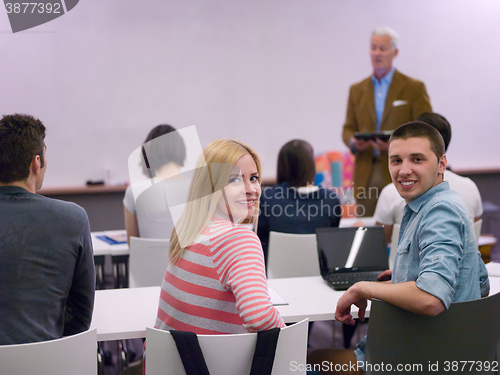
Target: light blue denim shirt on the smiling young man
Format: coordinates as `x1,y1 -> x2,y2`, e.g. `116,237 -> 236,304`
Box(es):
356,182 -> 490,368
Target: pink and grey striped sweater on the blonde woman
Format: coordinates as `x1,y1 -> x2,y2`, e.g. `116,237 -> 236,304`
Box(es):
156,218 -> 284,334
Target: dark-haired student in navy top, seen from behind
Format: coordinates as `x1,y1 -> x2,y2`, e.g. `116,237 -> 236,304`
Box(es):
257,139 -> 342,261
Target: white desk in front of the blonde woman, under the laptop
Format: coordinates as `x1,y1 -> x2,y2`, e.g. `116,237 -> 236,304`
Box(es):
91,276 -> 500,341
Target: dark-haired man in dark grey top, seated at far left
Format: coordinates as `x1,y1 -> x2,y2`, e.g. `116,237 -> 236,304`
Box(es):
0,114 -> 96,345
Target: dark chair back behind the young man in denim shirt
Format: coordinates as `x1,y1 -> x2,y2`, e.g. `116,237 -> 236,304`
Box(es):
366,293 -> 500,374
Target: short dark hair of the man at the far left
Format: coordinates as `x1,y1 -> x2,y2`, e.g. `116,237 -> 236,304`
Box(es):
0,113 -> 45,184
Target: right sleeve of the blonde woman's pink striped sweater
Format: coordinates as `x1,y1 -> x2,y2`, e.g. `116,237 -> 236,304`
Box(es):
212,227 -> 285,332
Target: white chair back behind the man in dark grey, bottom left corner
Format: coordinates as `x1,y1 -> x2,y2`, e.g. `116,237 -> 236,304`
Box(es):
0,329 -> 97,375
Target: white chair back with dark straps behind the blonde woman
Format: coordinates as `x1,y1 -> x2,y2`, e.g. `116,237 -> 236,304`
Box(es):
146,319 -> 308,375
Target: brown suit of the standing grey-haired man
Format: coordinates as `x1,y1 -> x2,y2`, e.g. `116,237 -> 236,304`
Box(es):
342,70 -> 432,200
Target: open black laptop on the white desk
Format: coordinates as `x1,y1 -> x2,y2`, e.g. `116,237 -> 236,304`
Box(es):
316,227 -> 389,290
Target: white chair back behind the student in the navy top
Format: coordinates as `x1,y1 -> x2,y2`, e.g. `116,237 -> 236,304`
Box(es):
267,232 -> 320,279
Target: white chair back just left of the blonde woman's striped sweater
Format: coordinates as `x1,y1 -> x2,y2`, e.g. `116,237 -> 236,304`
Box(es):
129,237 -> 169,288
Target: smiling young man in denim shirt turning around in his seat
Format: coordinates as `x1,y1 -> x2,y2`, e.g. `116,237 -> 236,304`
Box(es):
308,121 -> 489,373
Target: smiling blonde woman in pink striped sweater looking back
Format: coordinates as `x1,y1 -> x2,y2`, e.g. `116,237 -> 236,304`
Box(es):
156,140 -> 284,334
